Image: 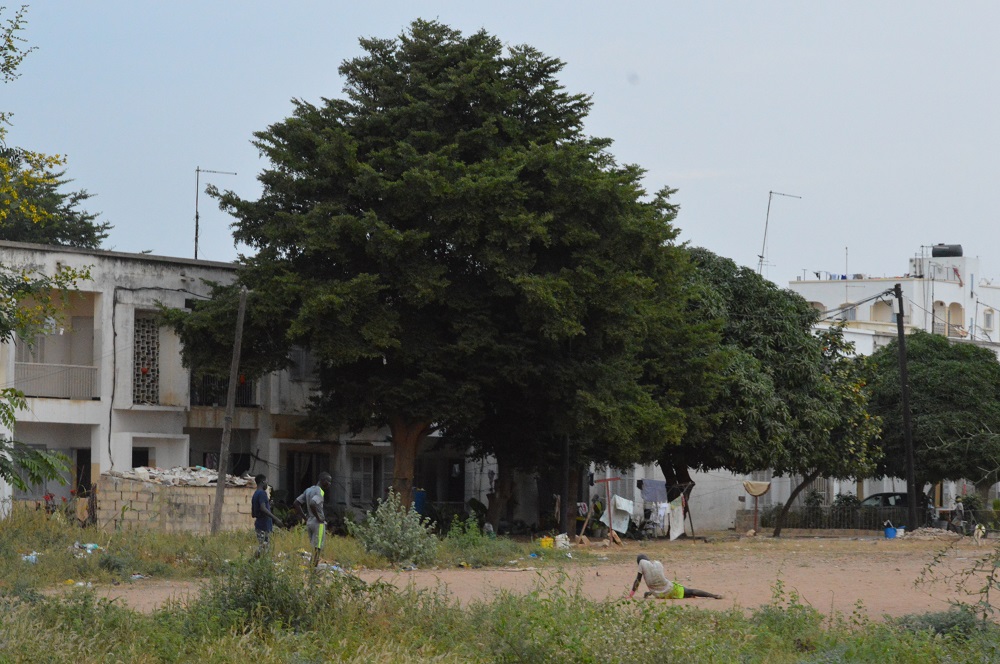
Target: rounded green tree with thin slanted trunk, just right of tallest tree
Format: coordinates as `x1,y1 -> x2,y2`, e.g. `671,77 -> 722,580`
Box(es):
660,249 -> 878,534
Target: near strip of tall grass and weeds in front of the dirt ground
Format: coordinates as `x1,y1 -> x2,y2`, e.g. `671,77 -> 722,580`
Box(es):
0,559 -> 1000,663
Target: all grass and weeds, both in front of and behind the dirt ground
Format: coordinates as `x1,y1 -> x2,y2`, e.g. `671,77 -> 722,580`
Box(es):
0,510 -> 1000,663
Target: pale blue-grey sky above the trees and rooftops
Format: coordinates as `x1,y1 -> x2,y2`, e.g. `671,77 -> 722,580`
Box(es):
7,0 -> 1000,285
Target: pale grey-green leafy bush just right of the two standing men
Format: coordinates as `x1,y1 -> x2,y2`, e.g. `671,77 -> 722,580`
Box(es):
347,489 -> 438,564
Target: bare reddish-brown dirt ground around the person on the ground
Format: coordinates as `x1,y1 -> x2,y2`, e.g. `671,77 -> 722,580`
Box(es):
74,533 -> 998,618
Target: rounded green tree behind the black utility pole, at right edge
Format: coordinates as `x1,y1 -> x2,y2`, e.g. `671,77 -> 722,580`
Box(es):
869,331 -> 1000,496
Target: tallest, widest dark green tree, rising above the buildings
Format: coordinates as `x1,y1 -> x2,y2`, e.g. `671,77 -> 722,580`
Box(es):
175,21 -> 704,508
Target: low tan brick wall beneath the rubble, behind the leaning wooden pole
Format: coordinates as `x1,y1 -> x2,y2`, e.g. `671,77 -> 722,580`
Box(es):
97,475 -> 255,535
